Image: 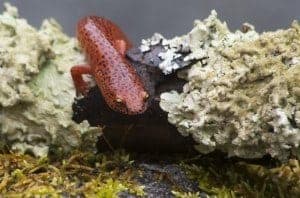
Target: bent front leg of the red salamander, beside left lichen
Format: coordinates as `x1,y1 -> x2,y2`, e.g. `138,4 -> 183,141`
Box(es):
71,65 -> 91,95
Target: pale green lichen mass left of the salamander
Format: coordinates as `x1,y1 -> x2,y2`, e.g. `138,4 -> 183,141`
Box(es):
0,4 -> 100,156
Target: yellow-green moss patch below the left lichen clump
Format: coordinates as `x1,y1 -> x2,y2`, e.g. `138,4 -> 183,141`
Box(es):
0,151 -> 145,197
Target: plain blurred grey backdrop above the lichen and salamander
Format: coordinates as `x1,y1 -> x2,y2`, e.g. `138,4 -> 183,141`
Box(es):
0,0 -> 300,43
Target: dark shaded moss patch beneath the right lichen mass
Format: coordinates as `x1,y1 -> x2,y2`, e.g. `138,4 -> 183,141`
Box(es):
179,156 -> 300,197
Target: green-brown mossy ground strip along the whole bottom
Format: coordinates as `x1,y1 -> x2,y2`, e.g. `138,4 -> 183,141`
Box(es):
0,151 -> 300,197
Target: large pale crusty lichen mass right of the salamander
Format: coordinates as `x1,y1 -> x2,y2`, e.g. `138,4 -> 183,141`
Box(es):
160,12 -> 300,160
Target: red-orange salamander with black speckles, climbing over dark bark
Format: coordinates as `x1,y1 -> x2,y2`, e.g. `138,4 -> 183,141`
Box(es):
71,16 -> 148,115
